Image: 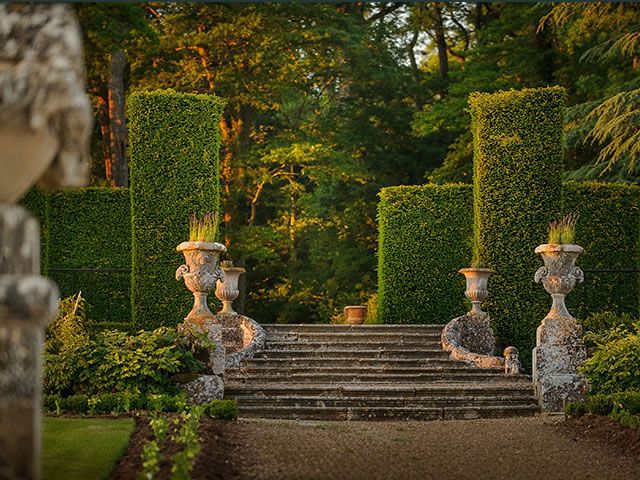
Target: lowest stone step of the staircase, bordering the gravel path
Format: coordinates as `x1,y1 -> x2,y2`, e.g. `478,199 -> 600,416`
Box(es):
232,404 -> 538,420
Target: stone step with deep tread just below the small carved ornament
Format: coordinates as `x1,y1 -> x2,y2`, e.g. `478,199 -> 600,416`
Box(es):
225,378 -> 533,398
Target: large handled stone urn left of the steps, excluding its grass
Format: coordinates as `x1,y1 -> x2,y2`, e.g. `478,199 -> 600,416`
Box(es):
176,242 -> 227,325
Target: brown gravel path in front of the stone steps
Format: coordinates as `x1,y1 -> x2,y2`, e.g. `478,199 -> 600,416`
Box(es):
225,417 -> 640,480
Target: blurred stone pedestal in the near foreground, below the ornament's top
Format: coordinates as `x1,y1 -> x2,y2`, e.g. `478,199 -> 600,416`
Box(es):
0,204 -> 58,479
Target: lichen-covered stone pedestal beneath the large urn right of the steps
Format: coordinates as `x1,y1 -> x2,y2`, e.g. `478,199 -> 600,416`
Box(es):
533,317 -> 587,412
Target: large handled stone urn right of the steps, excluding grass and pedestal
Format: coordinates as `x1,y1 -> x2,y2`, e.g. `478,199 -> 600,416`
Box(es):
534,243 -> 584,318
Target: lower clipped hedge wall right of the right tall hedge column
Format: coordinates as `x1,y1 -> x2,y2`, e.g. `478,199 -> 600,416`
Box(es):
564,182 -> 640,318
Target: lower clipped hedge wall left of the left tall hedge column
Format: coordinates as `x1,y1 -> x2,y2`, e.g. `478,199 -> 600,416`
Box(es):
48,188 -> 131,322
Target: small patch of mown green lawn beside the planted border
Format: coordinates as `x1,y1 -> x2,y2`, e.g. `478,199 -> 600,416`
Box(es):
42,417 -> 134,480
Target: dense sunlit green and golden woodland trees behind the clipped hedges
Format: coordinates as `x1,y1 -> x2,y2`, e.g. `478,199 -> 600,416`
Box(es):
77,2 -> 640,322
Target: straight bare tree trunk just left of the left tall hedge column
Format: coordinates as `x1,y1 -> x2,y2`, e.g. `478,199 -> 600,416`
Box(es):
109,50 -> 129,187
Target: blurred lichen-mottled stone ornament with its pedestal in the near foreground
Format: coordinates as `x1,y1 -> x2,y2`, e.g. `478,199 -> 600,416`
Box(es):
0,4 -> 91,479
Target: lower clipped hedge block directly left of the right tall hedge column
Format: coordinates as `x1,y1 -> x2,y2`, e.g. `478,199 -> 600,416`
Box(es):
378,185 -> 473,323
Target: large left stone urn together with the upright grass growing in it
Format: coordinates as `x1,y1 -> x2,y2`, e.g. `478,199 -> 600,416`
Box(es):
176,213 -> 227,324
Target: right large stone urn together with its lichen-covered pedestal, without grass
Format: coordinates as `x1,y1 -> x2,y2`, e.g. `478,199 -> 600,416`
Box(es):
532,244 -> 587,412
